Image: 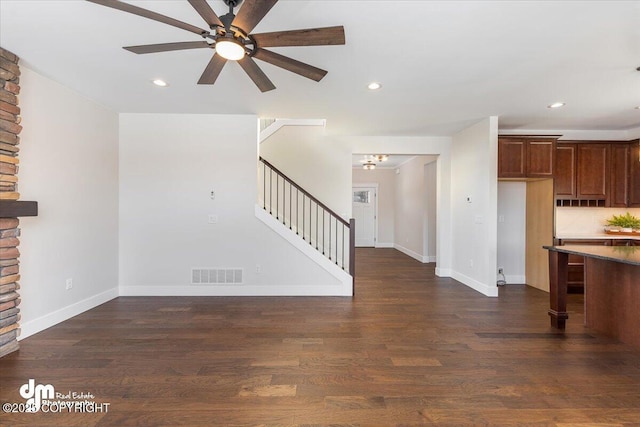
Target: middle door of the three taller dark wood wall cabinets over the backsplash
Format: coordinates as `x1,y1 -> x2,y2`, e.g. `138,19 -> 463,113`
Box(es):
576,143 -> 609,200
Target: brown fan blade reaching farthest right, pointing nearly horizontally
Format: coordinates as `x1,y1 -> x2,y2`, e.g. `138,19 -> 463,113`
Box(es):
251,26 -> 345,48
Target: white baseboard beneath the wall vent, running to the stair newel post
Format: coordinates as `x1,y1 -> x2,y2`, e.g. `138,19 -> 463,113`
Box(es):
120,284 -> 353,297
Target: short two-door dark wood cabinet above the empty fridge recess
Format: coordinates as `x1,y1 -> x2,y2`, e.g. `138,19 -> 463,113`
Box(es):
498,136 -> 556,178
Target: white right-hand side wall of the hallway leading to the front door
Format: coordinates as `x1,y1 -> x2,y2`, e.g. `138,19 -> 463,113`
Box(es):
394,156 -> 437,262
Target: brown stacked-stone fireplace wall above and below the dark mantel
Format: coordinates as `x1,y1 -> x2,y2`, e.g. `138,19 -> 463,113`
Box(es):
0,48 -> 22,357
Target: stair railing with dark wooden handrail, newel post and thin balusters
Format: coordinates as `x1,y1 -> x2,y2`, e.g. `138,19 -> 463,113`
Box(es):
258,157 -> 355,277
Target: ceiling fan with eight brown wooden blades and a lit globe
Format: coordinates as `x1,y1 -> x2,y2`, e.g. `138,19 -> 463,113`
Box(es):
87,0 -> 345,92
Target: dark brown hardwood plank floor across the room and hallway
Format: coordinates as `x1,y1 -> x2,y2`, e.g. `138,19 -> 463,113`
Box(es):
0,249 -> 640,427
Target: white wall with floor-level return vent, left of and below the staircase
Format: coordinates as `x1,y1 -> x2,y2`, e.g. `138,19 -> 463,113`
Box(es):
120,114 -> 344,295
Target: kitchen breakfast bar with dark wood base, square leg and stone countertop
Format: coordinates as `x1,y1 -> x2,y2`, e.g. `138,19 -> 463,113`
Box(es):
544,245 -> 640,348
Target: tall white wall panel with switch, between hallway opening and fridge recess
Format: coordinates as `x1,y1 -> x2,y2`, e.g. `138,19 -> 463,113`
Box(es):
451,117 -> 498,296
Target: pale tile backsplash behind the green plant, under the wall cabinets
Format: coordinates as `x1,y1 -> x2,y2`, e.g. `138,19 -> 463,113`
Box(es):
555,207 -> 640,236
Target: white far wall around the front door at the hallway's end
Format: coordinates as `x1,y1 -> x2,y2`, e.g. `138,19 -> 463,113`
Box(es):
353,168 -> 396,248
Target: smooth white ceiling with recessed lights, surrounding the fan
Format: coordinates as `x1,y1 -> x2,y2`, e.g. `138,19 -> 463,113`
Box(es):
0,0 -> 640,136
